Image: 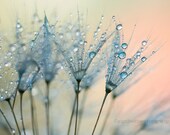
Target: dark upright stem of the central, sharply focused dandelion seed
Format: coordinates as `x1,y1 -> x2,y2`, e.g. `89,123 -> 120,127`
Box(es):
74,81 -> 80,135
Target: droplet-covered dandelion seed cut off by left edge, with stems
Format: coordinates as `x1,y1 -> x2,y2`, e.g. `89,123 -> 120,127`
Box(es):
0,43 -> 20,135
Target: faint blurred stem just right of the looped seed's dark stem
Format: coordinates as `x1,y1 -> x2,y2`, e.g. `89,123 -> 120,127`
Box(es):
29,89 -> 38,135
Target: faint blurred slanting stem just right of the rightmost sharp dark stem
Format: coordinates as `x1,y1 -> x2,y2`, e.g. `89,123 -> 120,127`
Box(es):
99,99 -> 114,135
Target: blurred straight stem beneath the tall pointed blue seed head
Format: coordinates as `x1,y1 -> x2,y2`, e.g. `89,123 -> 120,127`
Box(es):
45,81 -> 50,135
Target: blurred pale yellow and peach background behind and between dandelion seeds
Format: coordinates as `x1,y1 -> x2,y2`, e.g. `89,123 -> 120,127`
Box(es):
0,0 -> 170,135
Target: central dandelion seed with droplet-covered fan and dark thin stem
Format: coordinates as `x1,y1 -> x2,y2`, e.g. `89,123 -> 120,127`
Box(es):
53,12 -> 113,135
